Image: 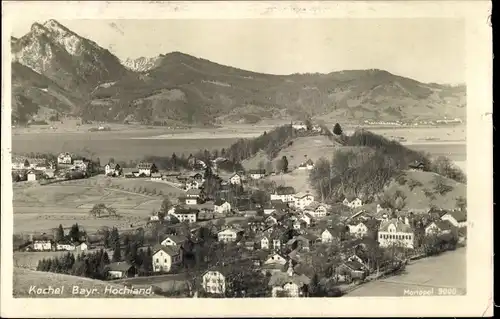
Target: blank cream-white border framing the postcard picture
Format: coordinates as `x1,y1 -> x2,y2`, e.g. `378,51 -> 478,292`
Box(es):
1,1 -> 493,318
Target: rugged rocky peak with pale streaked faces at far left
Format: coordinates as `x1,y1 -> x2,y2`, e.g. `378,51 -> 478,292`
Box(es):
12,20 -> 127,95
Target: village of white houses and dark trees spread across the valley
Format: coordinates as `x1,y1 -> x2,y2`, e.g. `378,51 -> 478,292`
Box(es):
12,139 -> 467,297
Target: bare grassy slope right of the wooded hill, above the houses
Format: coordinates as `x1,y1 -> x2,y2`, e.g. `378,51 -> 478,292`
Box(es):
385,171 -> 467,209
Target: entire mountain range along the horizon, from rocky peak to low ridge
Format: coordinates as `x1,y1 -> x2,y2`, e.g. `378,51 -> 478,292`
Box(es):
12,20 -> 466,124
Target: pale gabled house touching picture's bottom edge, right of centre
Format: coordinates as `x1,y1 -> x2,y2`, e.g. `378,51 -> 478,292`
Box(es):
269,263 -> 311,297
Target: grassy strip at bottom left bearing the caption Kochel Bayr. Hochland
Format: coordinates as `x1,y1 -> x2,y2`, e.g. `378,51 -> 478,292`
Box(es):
13,268 -> 159,298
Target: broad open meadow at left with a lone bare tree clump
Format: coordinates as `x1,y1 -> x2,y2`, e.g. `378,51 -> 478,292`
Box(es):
13,176 -> 182,234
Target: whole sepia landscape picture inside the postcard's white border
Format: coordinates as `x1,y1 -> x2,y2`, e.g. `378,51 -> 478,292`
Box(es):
2,1 -> 492,315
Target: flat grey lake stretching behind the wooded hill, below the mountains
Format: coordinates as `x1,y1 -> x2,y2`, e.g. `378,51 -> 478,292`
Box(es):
12,132 -> 466,161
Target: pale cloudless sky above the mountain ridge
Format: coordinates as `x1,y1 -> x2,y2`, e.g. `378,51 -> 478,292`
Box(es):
13,17 -> 466,84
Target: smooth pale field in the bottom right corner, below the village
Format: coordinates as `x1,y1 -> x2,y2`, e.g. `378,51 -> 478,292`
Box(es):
346,248 -> 467,297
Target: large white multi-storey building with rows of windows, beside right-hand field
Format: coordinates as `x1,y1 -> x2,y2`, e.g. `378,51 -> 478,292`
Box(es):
378,219 -> 415,248
